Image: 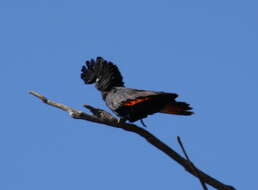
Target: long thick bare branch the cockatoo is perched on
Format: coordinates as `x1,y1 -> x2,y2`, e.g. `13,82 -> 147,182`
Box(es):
29,91 -> 235,190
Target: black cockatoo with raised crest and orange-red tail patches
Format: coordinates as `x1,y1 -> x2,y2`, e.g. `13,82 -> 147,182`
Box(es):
81,57 -> 193,122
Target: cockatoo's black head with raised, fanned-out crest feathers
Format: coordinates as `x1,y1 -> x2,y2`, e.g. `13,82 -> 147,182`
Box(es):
81,57 -> 124,92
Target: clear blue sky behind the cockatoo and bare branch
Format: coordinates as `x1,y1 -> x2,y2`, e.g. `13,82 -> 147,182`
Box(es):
0,0 -> 258,190
